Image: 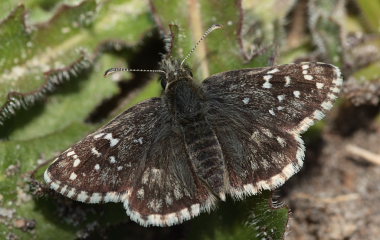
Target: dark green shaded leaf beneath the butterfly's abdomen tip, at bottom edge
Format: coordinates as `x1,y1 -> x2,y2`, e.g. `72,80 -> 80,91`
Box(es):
186,191 -> 289,240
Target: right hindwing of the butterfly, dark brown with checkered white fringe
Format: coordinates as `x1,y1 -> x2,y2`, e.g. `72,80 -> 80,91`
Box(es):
208,110 -> 304,198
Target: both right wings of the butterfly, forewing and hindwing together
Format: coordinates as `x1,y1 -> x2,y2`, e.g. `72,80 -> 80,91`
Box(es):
202,63 -> 342,197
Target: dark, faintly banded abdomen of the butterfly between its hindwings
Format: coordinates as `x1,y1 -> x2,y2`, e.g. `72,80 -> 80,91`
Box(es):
182,118 -> 226,199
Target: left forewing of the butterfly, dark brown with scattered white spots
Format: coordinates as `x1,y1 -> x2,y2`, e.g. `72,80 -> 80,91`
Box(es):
45,99 -> 161,202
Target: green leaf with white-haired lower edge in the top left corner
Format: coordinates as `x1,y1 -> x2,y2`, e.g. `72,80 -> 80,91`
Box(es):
0,1 -> 96,122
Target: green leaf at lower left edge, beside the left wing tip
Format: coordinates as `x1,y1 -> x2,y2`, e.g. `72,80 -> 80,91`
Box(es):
0,124 -> 91,239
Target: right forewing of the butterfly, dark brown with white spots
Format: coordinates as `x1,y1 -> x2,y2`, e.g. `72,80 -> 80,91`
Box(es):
203,63 -> 342,132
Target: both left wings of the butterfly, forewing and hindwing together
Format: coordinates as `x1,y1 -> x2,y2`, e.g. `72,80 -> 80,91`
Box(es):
45,98 -> 215,226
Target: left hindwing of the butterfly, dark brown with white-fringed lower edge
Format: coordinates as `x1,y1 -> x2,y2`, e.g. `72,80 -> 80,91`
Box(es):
124,134 -> 216,226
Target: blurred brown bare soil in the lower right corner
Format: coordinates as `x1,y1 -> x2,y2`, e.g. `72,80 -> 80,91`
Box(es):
282,103 -> 380,240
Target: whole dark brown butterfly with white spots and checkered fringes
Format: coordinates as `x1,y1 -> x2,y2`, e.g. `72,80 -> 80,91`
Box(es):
44,26 -> 342,226
